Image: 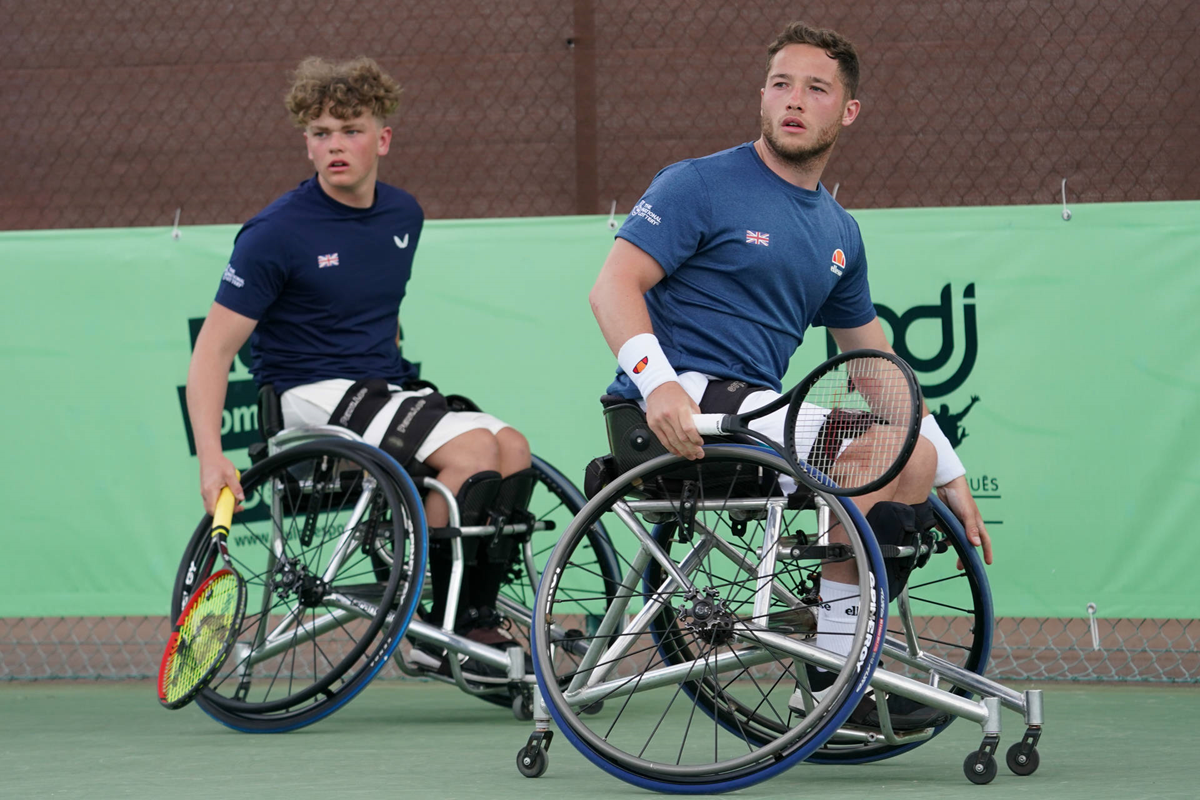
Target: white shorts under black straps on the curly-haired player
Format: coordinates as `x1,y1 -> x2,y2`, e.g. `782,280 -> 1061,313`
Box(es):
280,378 -> 511,462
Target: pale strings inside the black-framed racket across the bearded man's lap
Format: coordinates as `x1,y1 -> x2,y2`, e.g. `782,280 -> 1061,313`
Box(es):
793,356 -> 919,489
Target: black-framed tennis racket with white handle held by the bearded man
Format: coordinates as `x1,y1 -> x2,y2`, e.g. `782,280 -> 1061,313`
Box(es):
692,350 -> 922,495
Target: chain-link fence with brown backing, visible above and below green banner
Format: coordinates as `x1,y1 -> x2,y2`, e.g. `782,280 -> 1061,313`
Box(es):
0,0 -> 1200,682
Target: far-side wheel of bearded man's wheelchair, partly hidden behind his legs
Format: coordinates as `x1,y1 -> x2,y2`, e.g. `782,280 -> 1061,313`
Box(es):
809,497 -> 995,764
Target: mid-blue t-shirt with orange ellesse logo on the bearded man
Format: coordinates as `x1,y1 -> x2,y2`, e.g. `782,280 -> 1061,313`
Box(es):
608,143 -> 875,398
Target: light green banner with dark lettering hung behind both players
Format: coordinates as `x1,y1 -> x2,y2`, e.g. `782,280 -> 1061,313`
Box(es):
0,203 -> 1200,618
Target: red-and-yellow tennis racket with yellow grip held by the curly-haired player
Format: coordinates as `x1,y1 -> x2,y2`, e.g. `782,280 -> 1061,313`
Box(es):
158,479 -> 246,709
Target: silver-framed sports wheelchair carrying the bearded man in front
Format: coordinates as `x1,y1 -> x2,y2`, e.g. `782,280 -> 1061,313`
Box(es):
517,398 -> 1043,793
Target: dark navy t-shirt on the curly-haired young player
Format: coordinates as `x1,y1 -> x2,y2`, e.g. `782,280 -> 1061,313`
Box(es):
216,178 -> 425,392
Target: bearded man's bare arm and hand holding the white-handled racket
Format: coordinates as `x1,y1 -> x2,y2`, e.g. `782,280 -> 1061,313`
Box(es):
588,239 -> 703,458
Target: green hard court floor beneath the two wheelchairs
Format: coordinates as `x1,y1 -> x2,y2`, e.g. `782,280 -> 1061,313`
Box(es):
0,681 -> 1200,800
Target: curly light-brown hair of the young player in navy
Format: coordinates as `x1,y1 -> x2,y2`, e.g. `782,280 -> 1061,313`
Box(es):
283,56 -> 401,127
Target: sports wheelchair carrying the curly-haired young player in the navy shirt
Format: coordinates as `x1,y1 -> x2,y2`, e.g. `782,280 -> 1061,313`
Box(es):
172,386 -> 619,733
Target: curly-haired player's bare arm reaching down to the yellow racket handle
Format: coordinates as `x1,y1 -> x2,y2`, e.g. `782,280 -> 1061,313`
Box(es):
187,302 -> 258,513
